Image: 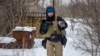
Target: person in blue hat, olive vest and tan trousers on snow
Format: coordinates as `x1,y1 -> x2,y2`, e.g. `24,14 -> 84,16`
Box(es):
40,6 -> 67,56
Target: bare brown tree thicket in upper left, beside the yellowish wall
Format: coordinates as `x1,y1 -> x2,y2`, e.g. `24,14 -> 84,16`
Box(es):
0,0 -> 39,36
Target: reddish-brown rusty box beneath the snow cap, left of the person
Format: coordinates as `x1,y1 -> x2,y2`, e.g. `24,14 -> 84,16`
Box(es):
13,31 -> 34,48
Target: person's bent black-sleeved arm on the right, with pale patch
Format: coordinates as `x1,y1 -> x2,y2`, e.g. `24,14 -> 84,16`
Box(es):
57,16 -> 68,30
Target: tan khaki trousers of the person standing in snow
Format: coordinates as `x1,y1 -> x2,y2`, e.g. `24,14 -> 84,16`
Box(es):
46,40 -> 63,56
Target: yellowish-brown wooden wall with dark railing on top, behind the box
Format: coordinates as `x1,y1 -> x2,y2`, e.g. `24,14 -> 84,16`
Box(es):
20,12 -> 46,38
